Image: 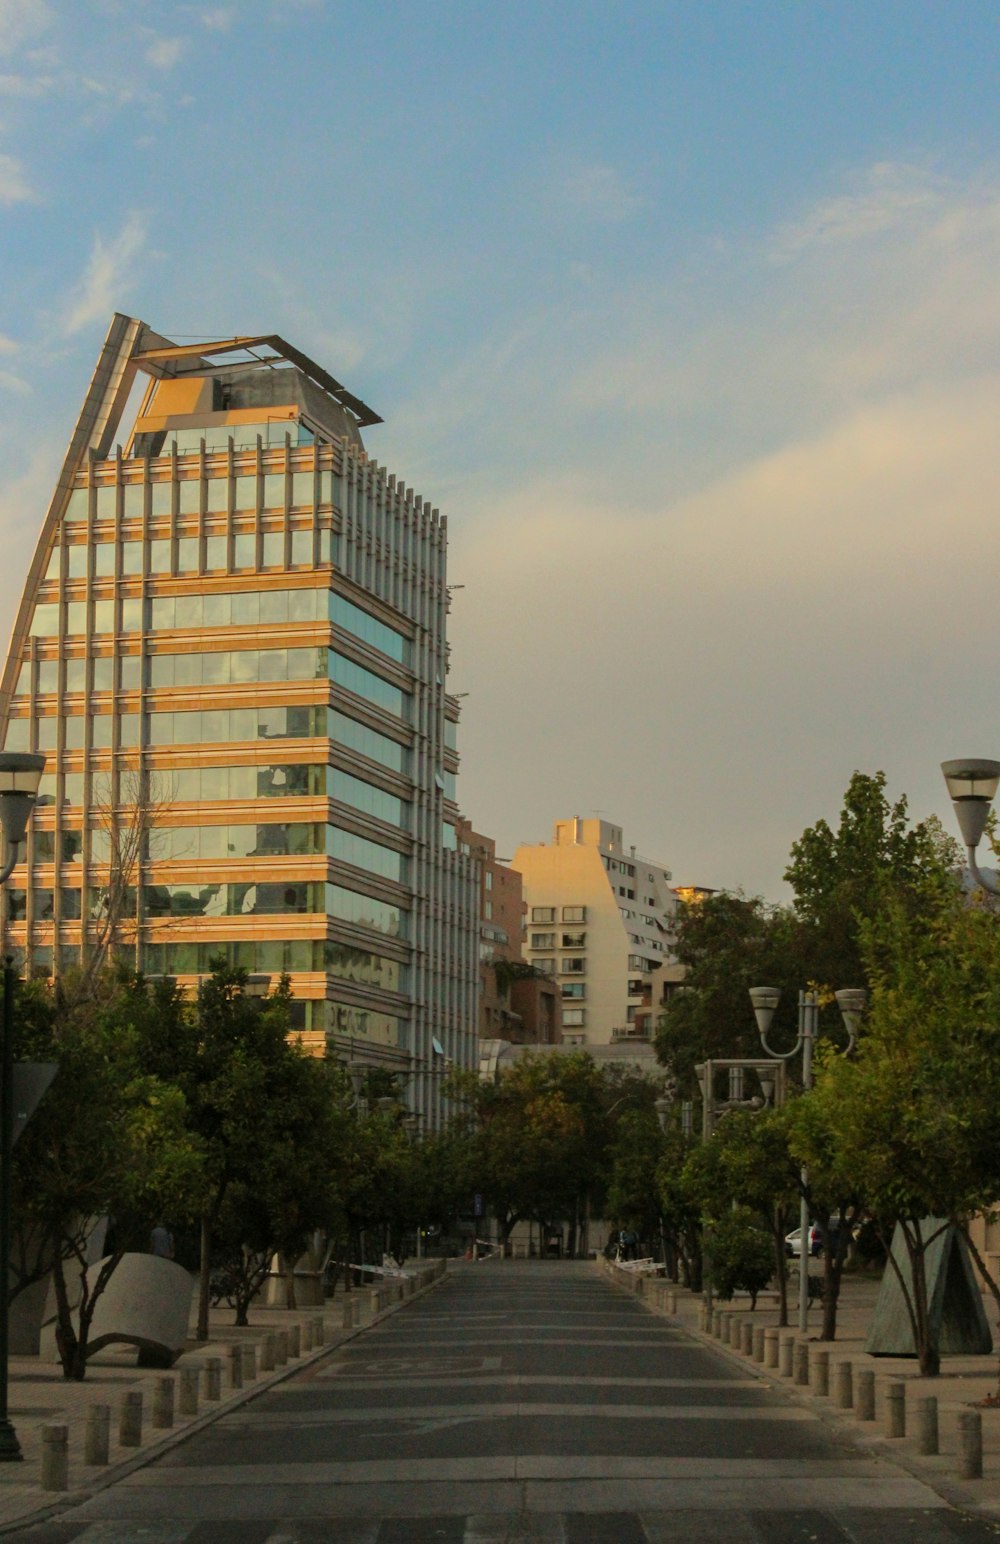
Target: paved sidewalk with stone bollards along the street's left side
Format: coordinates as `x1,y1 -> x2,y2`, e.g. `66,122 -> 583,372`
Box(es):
0,1260 -> 446,1533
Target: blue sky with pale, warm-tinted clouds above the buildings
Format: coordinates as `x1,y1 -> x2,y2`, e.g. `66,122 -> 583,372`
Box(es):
0,0 -> 1000,900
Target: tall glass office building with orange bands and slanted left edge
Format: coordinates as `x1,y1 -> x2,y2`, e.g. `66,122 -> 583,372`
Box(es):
0,315 -> 478,1119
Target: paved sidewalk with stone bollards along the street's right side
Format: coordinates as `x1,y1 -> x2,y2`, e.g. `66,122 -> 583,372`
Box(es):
599,1260 -> 1000,1521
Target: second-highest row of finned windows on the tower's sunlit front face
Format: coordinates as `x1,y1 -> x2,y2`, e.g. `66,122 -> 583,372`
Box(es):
45,525 -> 331,581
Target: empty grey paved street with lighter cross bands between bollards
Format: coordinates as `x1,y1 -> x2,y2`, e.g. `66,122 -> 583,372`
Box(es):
9,1261 -> 997,1544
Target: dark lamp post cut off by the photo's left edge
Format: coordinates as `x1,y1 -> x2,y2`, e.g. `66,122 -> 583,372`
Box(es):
0,750 -> 45,1462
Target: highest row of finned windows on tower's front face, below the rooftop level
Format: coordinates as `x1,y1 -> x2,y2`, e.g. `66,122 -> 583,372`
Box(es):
65,468 -> 333,525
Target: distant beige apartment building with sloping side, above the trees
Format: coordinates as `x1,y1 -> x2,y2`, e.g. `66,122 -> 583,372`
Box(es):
512,817 -> 677,1045
